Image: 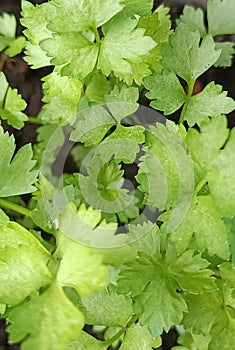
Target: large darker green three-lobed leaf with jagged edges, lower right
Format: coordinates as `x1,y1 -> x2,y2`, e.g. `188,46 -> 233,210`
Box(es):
117,243 -> 215,337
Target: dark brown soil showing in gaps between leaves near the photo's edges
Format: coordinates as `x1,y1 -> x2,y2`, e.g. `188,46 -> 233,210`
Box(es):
0,0 -> 235,350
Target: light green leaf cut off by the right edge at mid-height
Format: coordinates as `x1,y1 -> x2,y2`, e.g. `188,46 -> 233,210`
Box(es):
186,116 -> 235,216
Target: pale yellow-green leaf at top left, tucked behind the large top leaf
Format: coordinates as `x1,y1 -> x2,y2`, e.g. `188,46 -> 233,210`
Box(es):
20,0 -> 52,69
